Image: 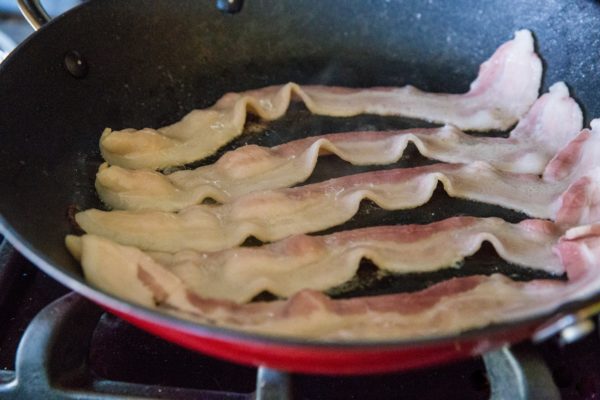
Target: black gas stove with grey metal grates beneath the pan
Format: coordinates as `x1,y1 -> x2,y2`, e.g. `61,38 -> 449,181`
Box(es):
0,5 -> 600,400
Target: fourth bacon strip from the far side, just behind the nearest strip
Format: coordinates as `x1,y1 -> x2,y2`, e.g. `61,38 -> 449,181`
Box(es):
67,217 -> 565,303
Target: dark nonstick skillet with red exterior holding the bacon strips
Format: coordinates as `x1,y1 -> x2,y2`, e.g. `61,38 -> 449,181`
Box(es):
0,0 -> 600,373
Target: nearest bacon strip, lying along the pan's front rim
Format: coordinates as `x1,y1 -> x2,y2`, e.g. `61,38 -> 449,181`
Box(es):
69,223 -> 600,341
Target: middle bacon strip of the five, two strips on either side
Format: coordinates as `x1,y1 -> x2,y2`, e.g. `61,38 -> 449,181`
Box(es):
75,120 -> 600,252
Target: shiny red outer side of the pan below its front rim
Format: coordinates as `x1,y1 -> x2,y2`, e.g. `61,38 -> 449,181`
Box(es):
101,304 -> 539,375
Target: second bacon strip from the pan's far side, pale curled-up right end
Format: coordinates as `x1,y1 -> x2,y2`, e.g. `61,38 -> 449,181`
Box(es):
96,82 -> 583,211
